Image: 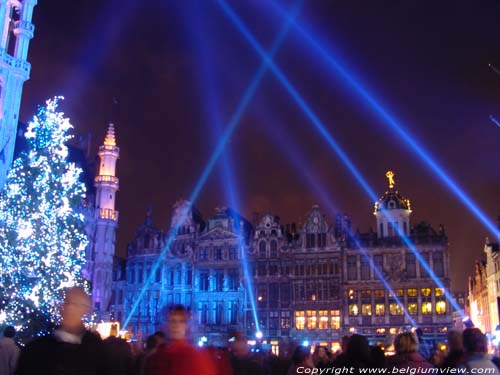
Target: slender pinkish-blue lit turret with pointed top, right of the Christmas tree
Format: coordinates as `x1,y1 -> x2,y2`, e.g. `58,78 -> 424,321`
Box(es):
91,124 -> 120,318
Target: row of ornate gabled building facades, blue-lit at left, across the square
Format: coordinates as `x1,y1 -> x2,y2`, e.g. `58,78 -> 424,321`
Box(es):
111,175 -> 453,349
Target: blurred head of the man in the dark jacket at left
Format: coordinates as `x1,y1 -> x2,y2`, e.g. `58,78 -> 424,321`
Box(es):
61,287 -> 92,328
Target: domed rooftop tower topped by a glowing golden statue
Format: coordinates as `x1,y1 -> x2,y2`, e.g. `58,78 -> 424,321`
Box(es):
373,171 -> 411,238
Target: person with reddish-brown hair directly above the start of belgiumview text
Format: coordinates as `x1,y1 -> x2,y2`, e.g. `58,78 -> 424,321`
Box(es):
387,332 -> 433,369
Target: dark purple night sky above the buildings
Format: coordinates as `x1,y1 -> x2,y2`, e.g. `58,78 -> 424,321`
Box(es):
17,0 -> 500,290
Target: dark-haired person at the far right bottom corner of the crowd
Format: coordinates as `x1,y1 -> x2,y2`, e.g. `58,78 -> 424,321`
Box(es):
461,328 -> 500,375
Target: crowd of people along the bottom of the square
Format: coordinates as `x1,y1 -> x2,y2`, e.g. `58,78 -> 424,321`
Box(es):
0,288 -> 500,375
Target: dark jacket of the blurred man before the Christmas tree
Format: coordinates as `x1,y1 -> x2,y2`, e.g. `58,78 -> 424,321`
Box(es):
16,331 -> 109,375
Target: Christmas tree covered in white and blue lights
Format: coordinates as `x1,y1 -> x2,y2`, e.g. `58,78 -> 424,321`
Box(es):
0,97 -> 87,337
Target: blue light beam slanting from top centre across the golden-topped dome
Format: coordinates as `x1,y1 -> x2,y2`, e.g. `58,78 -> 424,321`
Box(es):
218,0 -> 460,313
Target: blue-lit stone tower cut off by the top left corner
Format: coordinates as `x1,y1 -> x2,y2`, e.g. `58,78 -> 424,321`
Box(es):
0,0 -> 37,188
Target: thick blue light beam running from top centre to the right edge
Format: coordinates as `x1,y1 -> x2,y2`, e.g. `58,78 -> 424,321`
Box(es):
271,2 -> 500,241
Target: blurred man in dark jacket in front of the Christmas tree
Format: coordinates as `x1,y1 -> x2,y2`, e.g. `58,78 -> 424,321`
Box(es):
15,287 -> 110,375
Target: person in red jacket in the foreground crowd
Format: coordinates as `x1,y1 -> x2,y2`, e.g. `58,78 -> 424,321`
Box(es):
144,305 -> 216,375
